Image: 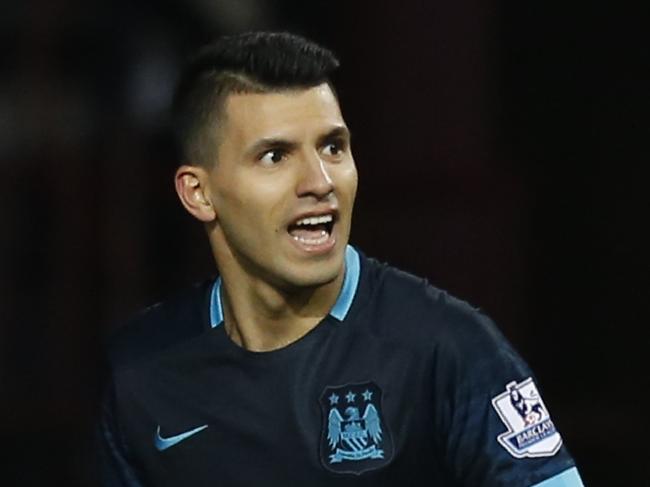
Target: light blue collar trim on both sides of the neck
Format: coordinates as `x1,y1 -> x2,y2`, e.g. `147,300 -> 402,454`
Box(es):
210,245 -> 361,328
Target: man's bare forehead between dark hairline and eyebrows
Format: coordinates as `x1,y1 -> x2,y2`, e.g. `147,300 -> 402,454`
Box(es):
224,83 -> 345,144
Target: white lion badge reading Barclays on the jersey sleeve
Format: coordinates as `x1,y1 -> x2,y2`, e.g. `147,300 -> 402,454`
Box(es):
492,377 -> 562,458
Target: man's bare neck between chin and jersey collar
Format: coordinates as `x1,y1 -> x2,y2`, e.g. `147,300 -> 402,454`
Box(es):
215,246 -> 345,352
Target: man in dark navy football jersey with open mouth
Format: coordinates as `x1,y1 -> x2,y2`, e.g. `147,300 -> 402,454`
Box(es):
101,33 -> 582,487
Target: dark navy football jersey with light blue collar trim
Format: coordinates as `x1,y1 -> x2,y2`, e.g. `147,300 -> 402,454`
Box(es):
100,247 -> 582,487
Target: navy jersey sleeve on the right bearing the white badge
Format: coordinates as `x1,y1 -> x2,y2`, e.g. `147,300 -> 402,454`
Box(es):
433,305 -> 582,487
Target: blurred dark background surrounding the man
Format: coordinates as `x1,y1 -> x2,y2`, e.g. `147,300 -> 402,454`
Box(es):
0,0 -> 650,487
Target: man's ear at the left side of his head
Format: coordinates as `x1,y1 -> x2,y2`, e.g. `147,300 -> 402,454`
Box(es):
174,165 -> 217,223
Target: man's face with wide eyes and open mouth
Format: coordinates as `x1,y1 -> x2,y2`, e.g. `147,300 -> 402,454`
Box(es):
209,84 -> 357,289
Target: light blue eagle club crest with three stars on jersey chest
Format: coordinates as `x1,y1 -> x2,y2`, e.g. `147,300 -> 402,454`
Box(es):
320,382 -> 393,474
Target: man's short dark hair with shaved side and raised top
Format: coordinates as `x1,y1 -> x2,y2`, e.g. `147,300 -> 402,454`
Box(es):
172,32 -> 339,164
